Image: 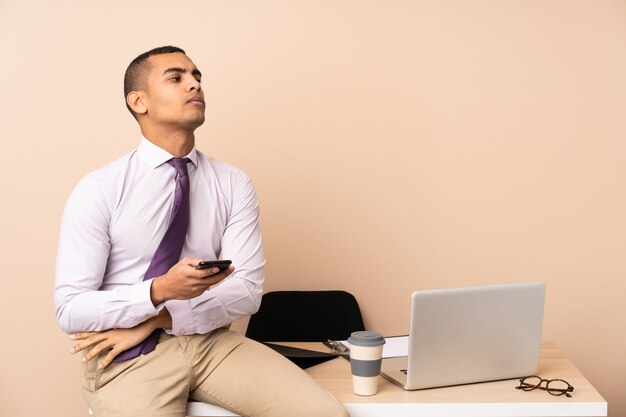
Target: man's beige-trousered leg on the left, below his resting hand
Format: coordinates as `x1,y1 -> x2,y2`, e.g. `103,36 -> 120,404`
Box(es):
82,333 -> 191,417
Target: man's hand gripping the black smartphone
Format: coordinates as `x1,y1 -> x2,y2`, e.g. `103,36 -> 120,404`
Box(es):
150,258 -> 235,305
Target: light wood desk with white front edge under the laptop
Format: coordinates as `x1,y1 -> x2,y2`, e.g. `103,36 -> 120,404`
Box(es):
187,342 -> 607,417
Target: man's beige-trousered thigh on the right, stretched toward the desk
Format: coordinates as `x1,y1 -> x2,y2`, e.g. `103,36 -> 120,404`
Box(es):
190,330 -> 348,417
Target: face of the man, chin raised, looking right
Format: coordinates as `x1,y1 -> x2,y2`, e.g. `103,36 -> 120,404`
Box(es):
143,52 -> 205,130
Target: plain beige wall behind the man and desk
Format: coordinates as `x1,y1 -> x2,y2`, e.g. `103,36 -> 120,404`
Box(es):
0,0 -> 626,417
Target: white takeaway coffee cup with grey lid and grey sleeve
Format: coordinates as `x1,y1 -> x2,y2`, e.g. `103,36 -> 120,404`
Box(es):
348,331 -> 385,395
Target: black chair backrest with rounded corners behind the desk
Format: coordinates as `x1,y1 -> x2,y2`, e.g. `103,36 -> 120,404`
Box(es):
246,291 -> 365,342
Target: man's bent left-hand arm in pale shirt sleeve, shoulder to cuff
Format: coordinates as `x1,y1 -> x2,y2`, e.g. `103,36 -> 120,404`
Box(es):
54,171 -> 163,333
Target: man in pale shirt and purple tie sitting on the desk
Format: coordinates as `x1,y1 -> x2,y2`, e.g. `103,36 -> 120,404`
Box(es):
55,47 -> 347,417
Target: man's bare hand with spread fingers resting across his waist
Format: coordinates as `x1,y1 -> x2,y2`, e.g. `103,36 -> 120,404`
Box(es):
70,308 -> 172,369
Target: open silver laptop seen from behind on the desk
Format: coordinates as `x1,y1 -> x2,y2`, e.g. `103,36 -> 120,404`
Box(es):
381,282 -> 545,390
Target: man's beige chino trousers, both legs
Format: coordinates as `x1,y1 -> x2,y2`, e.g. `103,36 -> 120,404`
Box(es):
82,329 -> 348,417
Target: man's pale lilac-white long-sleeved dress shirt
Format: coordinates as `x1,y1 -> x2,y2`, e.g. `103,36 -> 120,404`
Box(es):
55,138 -> 265,335
